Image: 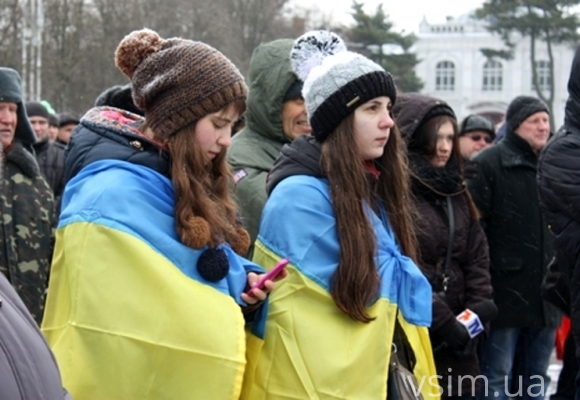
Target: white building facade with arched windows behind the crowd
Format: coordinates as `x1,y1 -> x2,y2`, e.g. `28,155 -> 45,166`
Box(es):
415,13 -> 575,129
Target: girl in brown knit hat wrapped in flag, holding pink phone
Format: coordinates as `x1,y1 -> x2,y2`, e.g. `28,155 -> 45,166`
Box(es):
42,29 -> 284,399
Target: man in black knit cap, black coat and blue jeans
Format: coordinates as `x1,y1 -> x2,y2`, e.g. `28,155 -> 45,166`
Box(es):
468,96 -> 561,400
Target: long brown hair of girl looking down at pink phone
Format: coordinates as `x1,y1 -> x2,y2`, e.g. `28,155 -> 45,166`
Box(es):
166,100 -> 246,248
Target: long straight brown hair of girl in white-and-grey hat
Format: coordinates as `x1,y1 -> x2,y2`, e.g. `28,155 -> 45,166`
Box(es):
321,114 -> 417,322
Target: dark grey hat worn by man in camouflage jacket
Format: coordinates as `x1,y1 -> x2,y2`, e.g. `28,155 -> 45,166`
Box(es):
0,67 -> 36,144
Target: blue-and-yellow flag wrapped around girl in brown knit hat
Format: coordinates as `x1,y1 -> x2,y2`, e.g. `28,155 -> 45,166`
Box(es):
42,107 -> 260,400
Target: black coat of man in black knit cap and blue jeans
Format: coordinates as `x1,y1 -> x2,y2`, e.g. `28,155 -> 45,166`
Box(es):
468,130 -> 560,328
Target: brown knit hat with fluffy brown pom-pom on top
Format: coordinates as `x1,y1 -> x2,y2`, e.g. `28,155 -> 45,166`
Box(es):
115,29 -> 248,139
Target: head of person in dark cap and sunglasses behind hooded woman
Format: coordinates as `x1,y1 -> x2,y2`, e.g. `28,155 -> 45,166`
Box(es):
459,114 -> 495,160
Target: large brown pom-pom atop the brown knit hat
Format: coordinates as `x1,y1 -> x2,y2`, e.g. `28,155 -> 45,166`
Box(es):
115,28 -> 162,78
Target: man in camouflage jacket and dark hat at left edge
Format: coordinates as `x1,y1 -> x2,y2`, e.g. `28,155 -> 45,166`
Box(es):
0,67 -> 54,323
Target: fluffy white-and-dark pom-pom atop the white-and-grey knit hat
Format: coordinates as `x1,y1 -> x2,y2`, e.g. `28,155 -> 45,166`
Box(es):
290,31 -> 346,81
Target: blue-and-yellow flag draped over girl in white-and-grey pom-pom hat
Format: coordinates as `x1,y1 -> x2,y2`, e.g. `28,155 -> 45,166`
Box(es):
242,139 -> 439,400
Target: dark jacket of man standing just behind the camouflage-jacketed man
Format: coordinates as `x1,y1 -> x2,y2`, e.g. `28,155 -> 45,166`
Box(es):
33,138 -> 64,198
